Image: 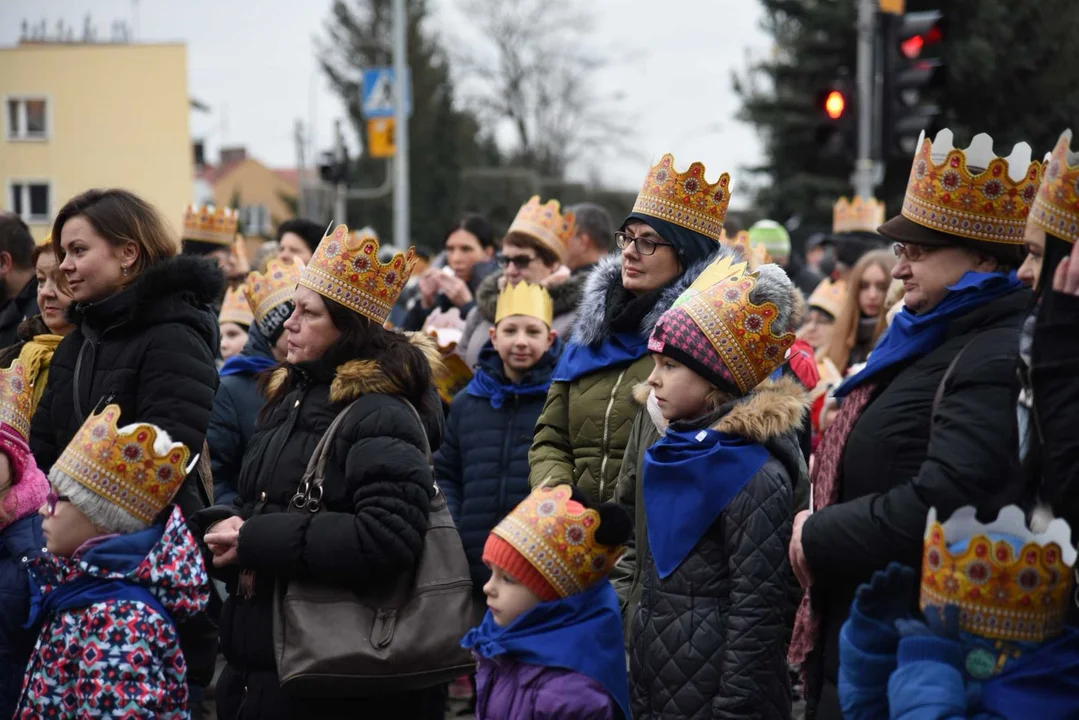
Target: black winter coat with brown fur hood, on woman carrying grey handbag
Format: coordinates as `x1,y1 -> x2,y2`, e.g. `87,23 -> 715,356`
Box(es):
195,338 -> 442,720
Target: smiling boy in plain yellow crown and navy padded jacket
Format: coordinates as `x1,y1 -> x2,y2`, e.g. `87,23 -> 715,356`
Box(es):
435,282 -> 562,616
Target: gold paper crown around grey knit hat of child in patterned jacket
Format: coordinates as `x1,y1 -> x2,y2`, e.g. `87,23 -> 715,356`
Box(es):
55,405 -> 193,525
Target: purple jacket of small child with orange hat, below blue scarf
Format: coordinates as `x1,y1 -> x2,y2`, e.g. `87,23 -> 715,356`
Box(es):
476,655 -> 622,720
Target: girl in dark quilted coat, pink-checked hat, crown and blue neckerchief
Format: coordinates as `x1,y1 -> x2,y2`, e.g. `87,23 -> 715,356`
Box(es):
619,250 -> 808,720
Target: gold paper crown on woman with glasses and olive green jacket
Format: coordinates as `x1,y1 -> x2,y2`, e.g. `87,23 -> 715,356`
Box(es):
633,153 -> 730,242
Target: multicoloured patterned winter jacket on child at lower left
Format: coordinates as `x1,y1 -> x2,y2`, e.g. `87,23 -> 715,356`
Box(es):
15,507 -> 209,720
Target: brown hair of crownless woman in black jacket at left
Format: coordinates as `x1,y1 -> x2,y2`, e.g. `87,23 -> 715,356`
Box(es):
53,188 -> 179,282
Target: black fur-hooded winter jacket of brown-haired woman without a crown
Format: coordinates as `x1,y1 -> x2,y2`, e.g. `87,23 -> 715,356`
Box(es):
30,256 -> 224,518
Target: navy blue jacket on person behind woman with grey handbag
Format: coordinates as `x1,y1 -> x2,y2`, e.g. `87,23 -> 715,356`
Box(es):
206,325 -> 275,505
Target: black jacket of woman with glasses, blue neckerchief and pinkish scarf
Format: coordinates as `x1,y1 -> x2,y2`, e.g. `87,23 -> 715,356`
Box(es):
802,290 -> 1030,718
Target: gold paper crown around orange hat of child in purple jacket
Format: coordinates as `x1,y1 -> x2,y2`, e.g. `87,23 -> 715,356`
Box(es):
491,485 -> 625,597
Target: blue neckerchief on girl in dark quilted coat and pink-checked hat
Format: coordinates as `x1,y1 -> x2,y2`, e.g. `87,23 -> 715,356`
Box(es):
642,430 -> 770,578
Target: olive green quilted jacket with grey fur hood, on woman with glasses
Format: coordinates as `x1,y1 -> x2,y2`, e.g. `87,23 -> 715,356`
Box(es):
529,250 -> 712,502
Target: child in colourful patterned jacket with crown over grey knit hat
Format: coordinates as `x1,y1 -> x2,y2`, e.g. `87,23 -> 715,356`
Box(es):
15,405 -> 208,720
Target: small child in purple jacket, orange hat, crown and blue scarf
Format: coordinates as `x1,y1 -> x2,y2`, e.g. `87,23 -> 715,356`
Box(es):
461,485 -> 631,720
